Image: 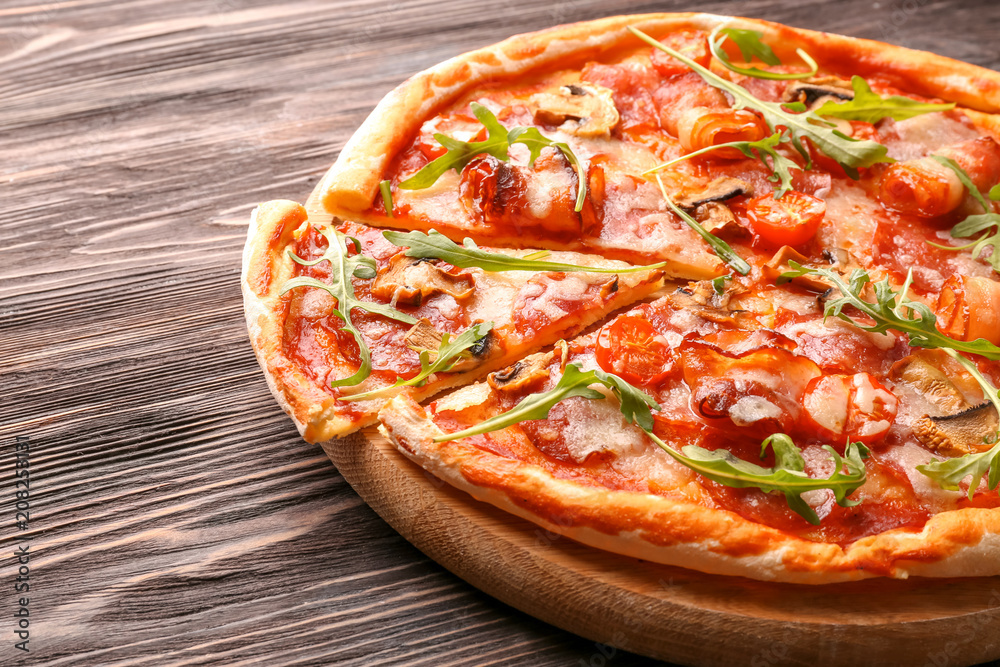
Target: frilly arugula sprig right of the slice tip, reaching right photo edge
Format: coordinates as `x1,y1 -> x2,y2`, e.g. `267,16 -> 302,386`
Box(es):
778,260 -> 1000,359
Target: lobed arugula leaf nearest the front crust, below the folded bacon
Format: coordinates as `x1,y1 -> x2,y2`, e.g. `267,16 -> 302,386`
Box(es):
646,431 -> 869,526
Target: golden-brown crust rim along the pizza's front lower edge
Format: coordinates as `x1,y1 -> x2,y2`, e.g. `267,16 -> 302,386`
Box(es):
380,397 -> 1000,584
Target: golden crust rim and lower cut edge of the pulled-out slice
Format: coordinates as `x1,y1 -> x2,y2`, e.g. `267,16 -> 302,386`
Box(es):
241,200 -> 663,442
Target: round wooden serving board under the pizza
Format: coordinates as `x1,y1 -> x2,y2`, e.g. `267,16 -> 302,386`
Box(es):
306,187 -> 1000,667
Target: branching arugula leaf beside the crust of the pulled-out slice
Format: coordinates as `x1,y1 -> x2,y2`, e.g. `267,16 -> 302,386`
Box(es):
281,228 -> 417,387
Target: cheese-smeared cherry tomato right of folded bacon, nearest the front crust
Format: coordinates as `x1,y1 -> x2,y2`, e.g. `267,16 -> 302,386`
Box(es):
802,373 -> 898,444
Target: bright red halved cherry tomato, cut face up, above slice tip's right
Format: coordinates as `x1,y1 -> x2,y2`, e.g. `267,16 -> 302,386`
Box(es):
747,190 -> 826,246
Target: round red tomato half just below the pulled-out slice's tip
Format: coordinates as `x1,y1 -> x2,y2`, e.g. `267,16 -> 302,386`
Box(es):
597,315 -> 676,386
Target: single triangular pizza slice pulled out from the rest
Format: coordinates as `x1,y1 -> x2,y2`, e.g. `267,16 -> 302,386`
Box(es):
242,201 -> 663,442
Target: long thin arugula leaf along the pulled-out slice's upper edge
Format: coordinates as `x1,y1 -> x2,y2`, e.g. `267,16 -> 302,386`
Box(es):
382,229 -> 667,273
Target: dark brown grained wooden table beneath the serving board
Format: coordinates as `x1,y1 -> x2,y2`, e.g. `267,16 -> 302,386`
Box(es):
0,0 -> 1000,666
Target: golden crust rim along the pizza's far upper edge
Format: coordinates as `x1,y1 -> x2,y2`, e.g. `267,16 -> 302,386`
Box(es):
321,14 -> 1000,217
